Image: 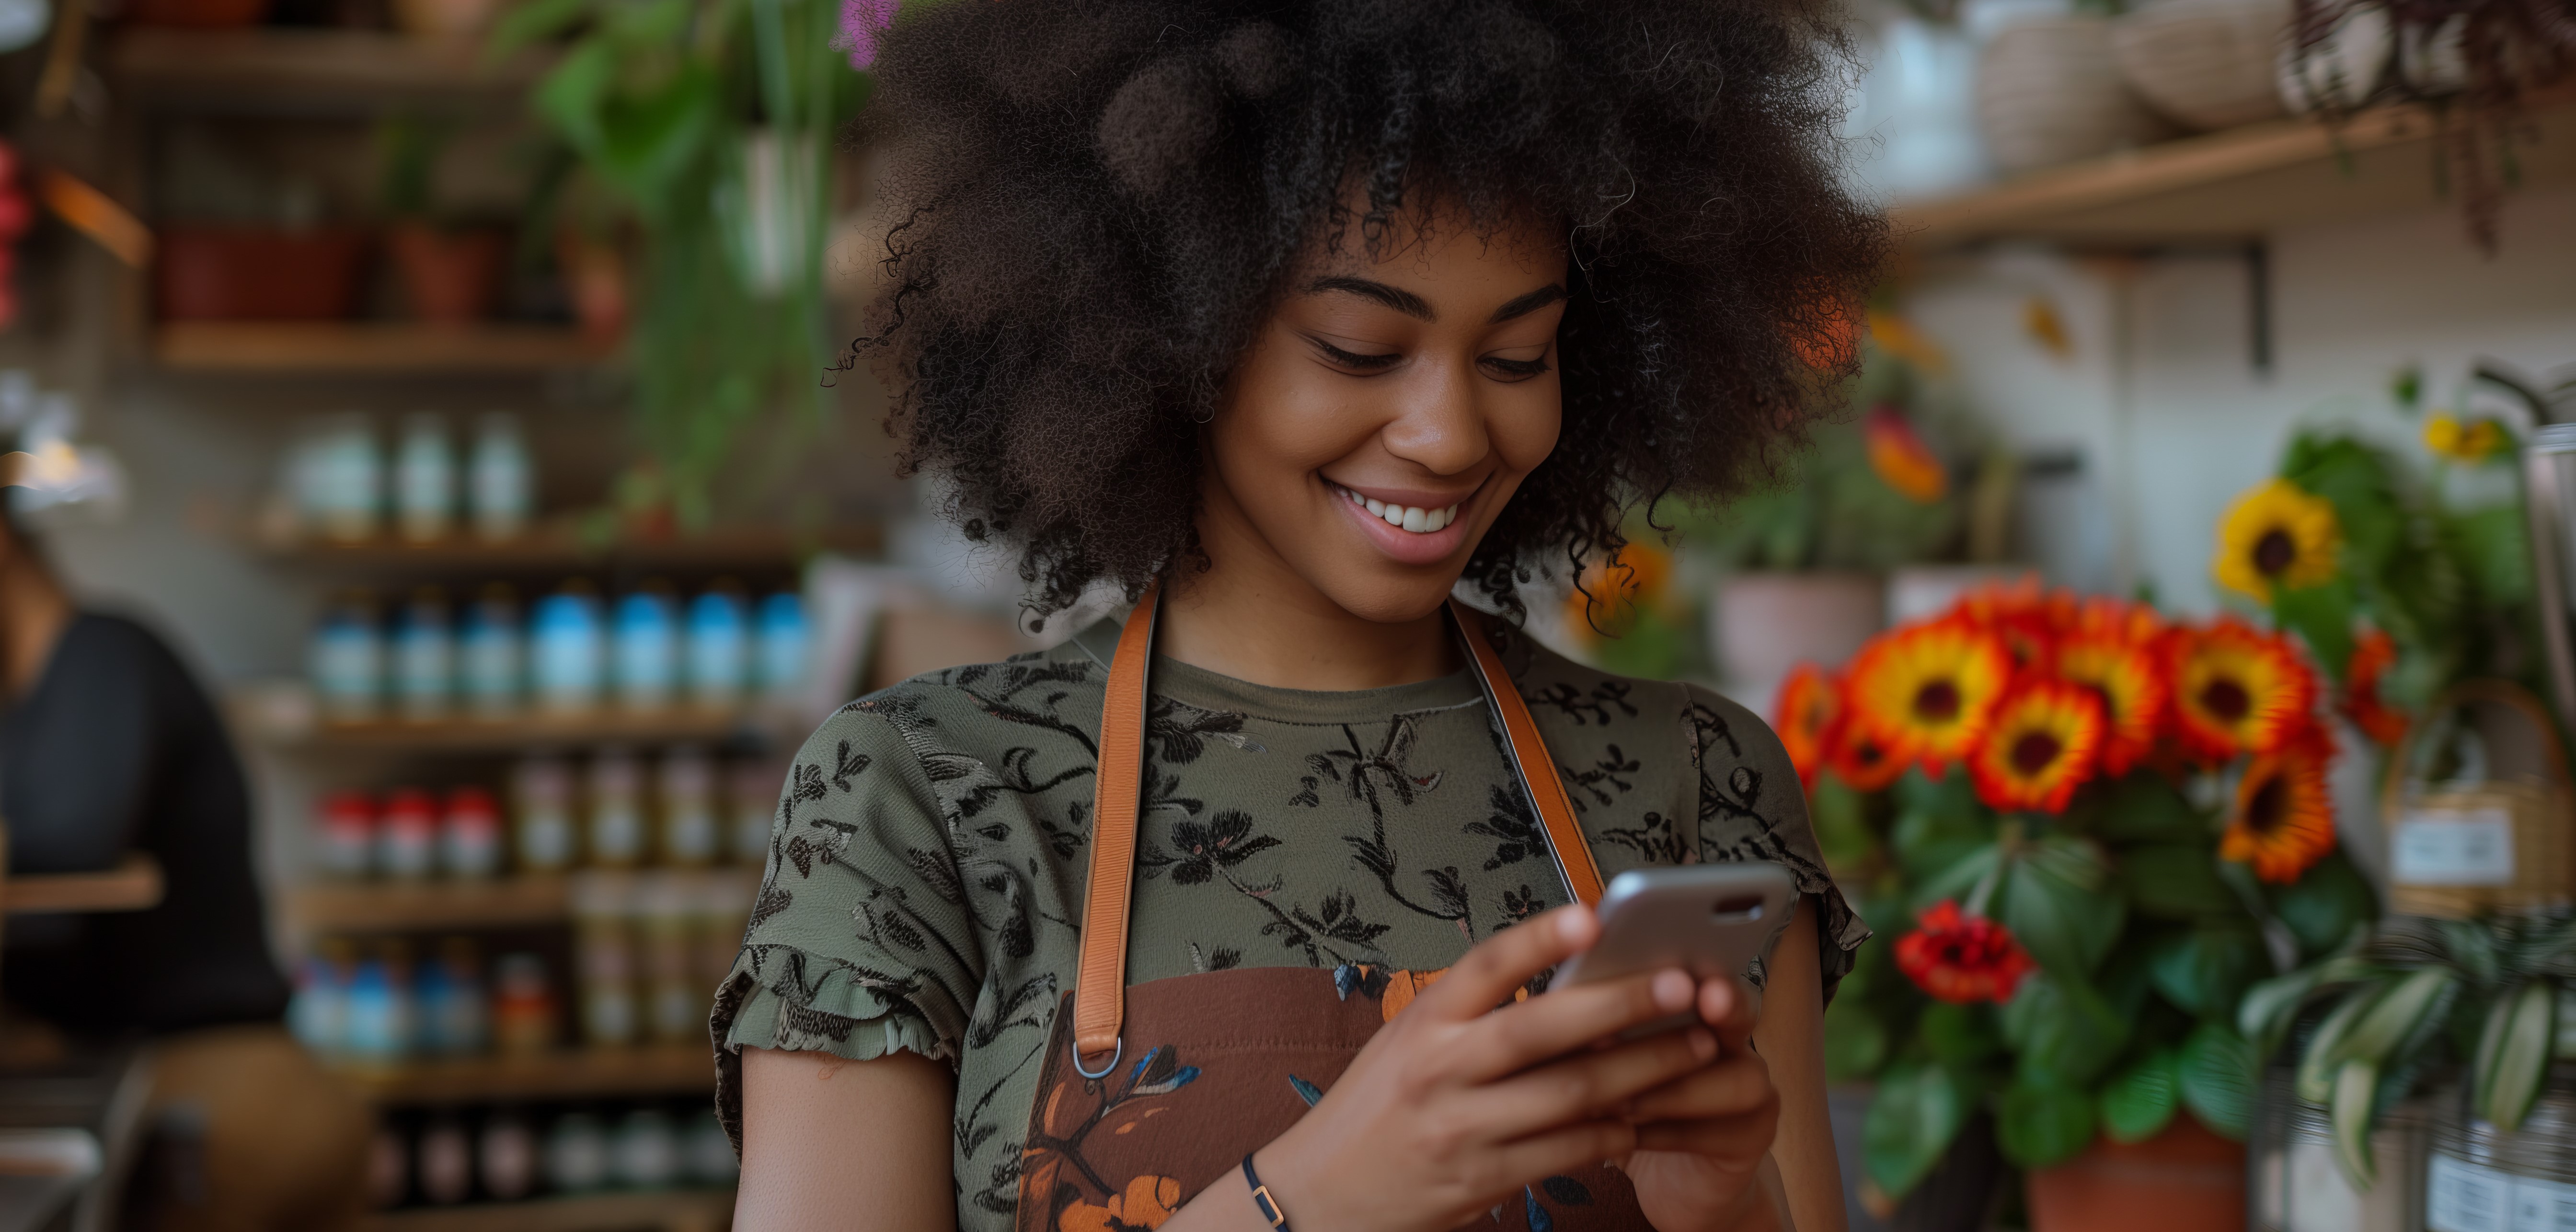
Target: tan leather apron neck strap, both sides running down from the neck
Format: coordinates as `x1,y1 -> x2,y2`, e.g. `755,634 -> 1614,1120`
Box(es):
1074,585 -> 1602,1077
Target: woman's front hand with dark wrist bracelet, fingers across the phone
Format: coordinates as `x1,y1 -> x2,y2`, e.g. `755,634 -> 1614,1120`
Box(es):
1216,905 -> 1718,1232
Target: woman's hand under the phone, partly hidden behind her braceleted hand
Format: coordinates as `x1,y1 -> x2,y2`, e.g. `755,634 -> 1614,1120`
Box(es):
1623,972 -> 1788,1232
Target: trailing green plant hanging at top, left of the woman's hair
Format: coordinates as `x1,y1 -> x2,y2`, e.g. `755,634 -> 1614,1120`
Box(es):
494,0 -> 891,526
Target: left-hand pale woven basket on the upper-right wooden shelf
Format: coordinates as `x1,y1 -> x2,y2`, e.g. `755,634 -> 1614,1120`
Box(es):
1976,15 -> 2172,173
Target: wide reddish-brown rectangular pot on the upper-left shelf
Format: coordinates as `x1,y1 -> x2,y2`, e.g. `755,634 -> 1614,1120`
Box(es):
152,227 -> 366,320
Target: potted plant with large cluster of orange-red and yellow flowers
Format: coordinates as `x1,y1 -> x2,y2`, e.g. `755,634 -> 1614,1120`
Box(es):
1777,585 -> 2375,1232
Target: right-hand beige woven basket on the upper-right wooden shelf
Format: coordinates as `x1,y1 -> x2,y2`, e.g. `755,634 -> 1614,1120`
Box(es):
2110,0 -> 2290,131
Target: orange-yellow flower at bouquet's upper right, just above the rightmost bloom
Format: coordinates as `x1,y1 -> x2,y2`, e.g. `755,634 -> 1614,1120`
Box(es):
2169,616 -> 2316,760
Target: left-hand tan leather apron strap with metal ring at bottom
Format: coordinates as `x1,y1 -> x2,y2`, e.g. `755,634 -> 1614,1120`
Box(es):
1074,585 -> 1162,1077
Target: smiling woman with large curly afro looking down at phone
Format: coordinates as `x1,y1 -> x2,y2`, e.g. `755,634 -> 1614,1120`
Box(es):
713,0 -> 1883,1232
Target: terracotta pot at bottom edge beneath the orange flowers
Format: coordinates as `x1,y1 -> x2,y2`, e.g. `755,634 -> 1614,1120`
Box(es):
2027,1114 -> 2246,1232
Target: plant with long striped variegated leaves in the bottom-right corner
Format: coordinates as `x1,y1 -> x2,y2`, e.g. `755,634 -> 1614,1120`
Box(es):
2239,915 -> 2576,1188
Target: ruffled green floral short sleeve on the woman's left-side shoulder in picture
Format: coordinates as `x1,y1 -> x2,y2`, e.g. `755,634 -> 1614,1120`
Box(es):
708,709 -> 984,1144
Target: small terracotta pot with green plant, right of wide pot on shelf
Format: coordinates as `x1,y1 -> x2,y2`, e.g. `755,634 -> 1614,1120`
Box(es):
376,116 -> 502,325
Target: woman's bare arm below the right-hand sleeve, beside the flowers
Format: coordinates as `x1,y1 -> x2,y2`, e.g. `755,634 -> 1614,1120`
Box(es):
1754,899 -> 1844,1232
